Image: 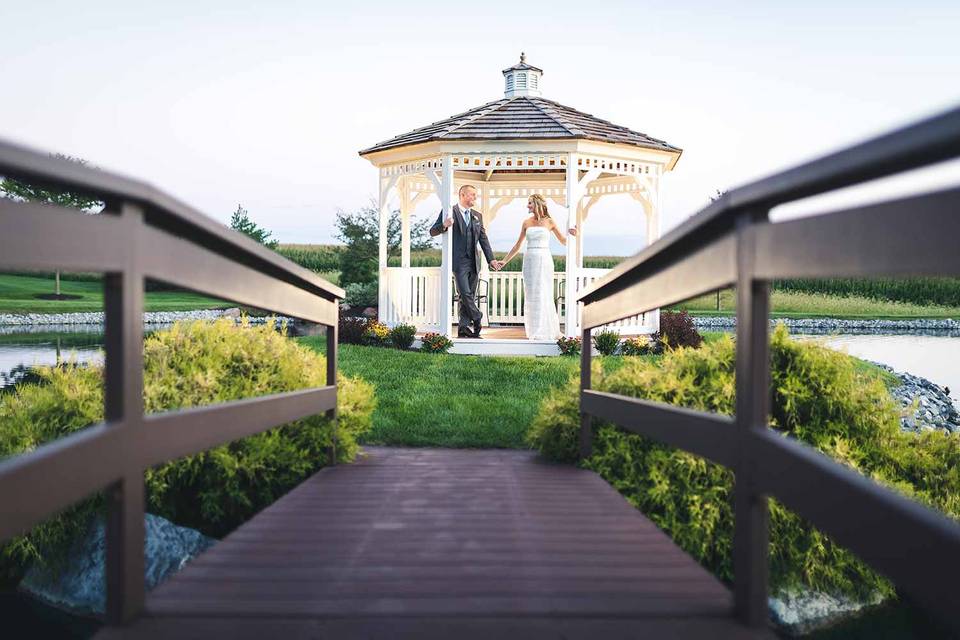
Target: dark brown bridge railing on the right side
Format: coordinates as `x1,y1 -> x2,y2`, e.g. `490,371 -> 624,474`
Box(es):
579,109 -> 960,631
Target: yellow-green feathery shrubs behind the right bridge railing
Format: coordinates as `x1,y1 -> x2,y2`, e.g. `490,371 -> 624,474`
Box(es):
528,326 -> 960,596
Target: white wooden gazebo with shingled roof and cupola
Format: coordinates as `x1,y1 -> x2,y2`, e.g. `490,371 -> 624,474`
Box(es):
360,54 -> 681,354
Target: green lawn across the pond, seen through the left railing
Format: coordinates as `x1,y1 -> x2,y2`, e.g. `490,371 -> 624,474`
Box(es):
0,274 -> 231,313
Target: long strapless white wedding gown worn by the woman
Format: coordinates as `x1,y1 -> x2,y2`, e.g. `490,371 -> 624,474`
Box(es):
523,227 -> 560,340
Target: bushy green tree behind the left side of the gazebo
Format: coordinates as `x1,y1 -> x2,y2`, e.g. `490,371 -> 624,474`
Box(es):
336,201 -> 433,286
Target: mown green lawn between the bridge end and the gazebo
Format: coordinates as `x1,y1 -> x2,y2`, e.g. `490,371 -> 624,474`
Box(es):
300,337 -> 622,448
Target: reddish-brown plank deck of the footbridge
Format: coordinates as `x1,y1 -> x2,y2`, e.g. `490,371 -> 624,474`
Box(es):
98,448 -> 772,638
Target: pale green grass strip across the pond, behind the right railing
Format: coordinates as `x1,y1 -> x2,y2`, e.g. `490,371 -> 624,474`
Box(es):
670,289 -> 960,320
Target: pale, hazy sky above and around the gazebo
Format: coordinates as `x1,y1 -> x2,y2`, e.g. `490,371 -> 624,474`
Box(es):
0,0 -> 960,255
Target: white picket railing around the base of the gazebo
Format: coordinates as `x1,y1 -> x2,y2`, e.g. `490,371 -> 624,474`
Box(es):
379,267 -> 657,334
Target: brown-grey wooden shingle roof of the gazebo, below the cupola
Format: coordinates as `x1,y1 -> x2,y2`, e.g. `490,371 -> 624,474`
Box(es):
360,96 -> 680,156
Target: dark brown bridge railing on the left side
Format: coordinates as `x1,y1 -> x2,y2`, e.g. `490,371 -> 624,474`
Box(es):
0,141 -> 343,624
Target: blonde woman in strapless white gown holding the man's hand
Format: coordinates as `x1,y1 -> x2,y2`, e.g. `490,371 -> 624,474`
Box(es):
491,193 -> 577,340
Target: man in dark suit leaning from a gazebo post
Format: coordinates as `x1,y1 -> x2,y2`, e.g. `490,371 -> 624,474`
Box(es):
430,184 -> 502,338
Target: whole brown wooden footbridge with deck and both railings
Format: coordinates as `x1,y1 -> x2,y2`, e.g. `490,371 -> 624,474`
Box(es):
0,110 -> 960,638
